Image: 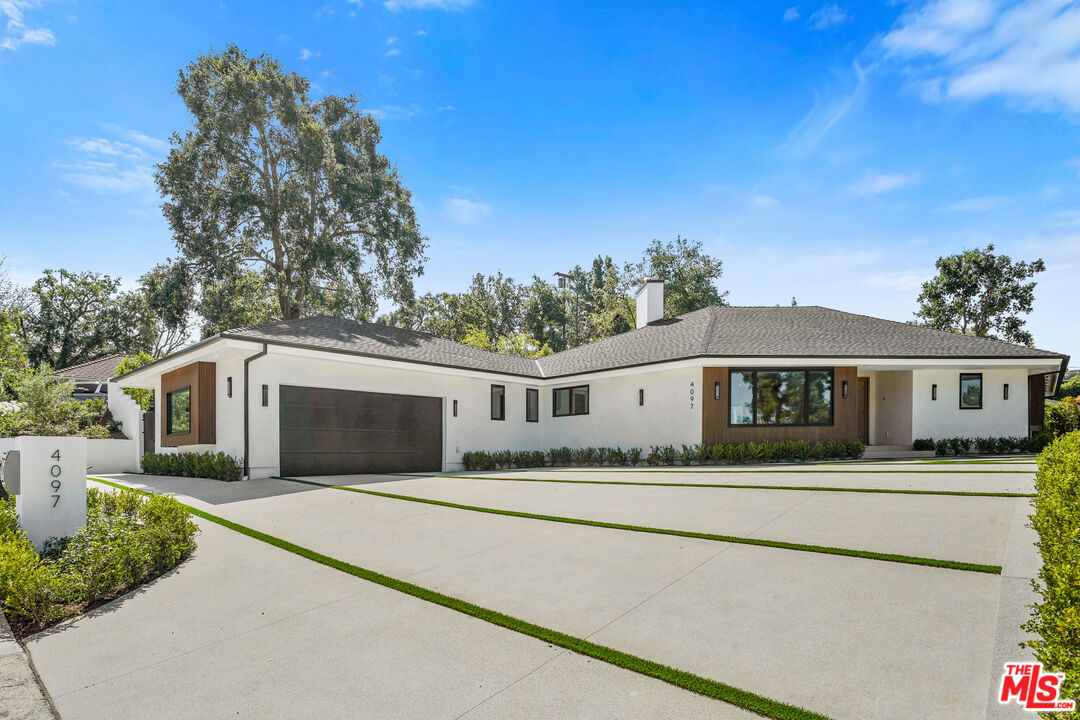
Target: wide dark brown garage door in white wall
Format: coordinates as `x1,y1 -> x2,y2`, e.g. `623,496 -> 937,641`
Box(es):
279,385 -> 443,476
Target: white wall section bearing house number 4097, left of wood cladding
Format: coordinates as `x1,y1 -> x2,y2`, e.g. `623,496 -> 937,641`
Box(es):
544,365 -> 703,453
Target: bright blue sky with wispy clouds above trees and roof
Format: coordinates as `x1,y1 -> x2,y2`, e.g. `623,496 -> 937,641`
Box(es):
0,0 -> 1080,358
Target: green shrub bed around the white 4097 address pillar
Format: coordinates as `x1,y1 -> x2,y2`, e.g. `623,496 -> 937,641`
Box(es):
0,488 -> 198,638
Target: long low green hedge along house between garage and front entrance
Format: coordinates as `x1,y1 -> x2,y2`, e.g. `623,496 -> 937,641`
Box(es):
461,440 -> 866,471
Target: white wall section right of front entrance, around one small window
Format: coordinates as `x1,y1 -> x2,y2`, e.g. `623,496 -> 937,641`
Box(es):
912,367 -> 1027,439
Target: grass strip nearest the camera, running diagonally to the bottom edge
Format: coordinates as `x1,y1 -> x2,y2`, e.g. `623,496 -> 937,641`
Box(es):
87,477 -> 829,720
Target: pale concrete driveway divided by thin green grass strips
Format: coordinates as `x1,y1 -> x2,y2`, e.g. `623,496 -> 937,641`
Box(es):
27,463 -> 1037,720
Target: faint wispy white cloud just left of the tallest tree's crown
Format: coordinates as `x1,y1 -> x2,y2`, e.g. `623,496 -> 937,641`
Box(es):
54,124 -> 168,199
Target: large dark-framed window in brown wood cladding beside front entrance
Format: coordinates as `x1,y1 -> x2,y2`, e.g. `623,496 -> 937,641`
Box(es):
728,369 -> 833,425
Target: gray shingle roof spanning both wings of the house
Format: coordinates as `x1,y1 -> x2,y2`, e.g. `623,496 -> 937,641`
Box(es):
214,305 -> 1064,378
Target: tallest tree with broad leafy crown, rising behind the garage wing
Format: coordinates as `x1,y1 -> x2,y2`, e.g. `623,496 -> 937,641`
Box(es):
156,45 -> 427,324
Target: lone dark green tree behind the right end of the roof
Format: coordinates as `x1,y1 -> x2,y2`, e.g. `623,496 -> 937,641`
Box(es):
916,245 -> 1047,345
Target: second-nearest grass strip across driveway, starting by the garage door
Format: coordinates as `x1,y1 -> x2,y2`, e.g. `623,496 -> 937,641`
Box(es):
276,477 -> 1001,575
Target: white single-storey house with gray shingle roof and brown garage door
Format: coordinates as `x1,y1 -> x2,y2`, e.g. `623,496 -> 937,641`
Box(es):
119,280 -> 1068,477
